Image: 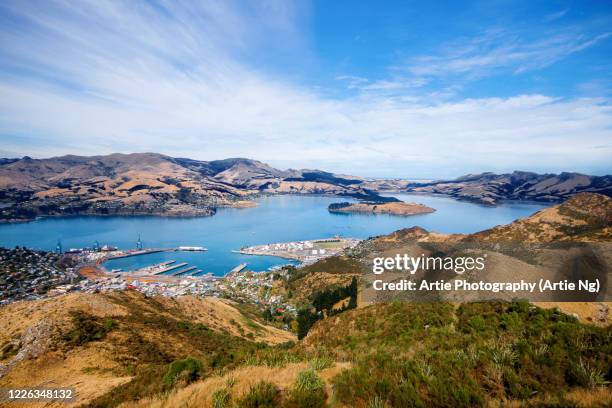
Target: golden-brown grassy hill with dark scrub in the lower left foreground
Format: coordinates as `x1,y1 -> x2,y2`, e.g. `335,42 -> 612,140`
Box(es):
0,291 -> 294,404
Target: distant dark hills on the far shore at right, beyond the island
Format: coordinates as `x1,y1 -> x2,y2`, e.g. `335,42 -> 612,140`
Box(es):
406,171 -> 612,205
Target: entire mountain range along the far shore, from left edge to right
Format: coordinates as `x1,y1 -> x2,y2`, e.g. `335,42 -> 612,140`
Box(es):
0,153 -> 612,220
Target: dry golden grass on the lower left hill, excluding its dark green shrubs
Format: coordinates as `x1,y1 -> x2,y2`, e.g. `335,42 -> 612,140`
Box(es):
0,291 -> 295,404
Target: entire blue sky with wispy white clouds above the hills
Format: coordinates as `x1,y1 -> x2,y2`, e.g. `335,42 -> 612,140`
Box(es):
0,0 -> 612,178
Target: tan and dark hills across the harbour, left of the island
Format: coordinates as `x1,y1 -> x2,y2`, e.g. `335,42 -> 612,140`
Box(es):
0,153 -> 388,220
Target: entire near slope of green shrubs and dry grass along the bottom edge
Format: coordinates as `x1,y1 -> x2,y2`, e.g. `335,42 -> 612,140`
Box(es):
77,301 -> 612,408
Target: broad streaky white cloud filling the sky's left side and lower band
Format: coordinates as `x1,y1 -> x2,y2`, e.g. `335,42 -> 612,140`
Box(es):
0,1 -> 612,176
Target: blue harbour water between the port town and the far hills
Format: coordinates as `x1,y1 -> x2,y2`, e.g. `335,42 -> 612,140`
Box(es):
0,194 -> 544,275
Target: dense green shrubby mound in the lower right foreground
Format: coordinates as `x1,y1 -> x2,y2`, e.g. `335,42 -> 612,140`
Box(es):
314,302 -> 612,407
